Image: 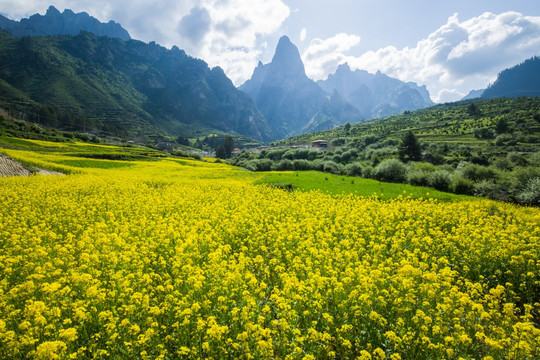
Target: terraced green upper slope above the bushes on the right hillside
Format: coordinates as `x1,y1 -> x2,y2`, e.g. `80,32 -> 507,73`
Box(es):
276,97 -> 540,151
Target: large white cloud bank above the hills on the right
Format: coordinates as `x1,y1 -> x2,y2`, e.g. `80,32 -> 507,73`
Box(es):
342,12 -> 540,102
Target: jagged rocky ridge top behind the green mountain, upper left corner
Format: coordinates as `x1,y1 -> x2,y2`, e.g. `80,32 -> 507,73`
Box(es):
0,6 -> 131,41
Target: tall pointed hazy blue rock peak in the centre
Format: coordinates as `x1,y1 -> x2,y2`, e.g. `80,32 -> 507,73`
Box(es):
240,36 -> 362,139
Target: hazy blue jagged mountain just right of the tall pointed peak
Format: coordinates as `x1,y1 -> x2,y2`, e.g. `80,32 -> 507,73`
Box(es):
318,64 -> 433,119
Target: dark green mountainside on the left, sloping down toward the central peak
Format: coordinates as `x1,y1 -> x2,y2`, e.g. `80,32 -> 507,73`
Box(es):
0,32 -> 270,143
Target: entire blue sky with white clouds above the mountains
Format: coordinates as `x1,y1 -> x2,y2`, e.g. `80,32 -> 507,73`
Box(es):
0,0 -> 540,102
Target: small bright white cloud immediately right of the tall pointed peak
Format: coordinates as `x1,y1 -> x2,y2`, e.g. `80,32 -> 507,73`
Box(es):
302,33 -> 360,80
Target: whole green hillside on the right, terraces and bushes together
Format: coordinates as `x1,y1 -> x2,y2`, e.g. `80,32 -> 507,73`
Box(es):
231,97 -> 540,205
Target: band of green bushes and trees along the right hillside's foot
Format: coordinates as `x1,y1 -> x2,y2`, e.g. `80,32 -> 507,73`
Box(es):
229,133 -> 540,206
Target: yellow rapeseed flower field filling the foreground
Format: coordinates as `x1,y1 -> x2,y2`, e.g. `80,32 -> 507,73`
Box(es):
0,142 -> 540,360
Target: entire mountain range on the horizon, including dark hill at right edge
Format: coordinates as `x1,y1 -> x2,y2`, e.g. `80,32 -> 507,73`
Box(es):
0,6 -> 540,146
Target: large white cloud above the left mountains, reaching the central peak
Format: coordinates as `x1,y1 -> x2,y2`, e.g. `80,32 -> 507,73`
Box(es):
2,0 -> 290,85
